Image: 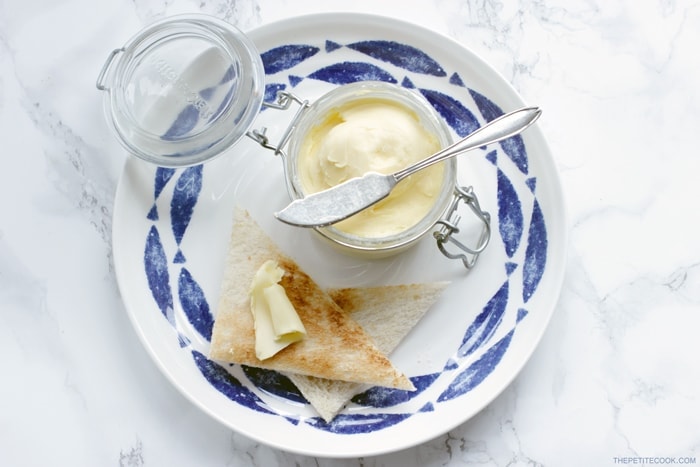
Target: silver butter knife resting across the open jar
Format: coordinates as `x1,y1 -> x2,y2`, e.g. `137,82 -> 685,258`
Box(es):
275,107 -> 542,227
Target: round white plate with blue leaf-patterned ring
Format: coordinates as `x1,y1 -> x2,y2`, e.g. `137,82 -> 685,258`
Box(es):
113,14 -> 567,457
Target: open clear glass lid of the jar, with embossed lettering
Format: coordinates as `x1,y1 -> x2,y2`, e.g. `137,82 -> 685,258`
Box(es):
97,15 -> 264,167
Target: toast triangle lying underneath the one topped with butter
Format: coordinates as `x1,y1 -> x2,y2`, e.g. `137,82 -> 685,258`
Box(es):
287,282 -> 449,422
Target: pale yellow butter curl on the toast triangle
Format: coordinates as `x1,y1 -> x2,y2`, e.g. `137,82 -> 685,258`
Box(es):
250,260 -> 306,360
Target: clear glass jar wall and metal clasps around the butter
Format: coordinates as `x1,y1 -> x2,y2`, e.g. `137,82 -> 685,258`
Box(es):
248,81 -> 491,269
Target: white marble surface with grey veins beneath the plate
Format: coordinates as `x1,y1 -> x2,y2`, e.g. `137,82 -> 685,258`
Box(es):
0,0 -> 700,467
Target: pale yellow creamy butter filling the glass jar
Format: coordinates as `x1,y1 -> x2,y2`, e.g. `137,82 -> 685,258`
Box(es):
297,97 -> 444,238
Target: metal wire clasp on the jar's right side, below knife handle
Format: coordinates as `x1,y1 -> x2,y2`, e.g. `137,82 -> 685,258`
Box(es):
433,186 -> 491,269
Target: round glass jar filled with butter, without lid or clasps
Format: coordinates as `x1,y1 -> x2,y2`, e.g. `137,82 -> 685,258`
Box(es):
287,82 -> 456,257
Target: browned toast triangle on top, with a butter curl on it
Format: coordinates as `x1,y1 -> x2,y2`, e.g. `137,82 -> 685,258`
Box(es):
209,209 -> 414,389
